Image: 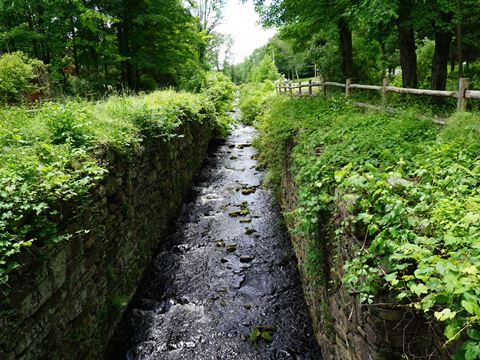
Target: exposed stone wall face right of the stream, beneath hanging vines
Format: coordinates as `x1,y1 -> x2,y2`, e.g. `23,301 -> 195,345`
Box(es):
280,140 -> 450,360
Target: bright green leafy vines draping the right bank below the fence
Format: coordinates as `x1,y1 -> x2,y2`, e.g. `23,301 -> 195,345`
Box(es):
258,97 -> 480,359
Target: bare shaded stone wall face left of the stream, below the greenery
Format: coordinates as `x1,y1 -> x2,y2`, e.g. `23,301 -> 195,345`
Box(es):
0,122 -> 211,360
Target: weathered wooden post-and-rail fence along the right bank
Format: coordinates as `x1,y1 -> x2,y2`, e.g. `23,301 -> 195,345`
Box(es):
276,78 -> 480,112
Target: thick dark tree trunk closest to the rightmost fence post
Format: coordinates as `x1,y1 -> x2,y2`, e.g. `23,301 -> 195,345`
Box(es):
432,30 -> 452,90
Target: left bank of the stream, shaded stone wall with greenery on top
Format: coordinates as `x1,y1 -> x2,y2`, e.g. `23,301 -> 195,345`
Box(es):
0,81 -> 233,359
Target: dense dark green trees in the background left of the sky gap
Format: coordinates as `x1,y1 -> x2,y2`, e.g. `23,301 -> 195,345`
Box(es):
0,0 -> 232,96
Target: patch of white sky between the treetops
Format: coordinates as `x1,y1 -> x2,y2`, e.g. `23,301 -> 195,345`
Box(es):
218,0 -> 275,64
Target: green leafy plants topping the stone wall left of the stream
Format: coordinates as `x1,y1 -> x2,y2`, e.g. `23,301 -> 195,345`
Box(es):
0,82 -> 234,292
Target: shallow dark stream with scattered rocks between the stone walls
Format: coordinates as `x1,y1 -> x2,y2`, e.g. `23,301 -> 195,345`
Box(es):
110,125 -> 320,360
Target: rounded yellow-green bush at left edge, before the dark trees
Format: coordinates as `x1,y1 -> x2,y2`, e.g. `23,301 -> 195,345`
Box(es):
0,52 -> 43,104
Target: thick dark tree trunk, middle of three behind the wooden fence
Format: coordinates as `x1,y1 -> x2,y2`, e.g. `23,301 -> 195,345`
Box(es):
397,3 -> 418,88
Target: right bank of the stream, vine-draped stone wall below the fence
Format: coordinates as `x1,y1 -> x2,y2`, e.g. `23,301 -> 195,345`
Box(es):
258,97 -> 480,359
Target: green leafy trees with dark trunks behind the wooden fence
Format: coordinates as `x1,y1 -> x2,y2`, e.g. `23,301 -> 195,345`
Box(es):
248,0 -> 480,93
